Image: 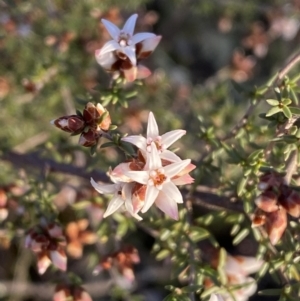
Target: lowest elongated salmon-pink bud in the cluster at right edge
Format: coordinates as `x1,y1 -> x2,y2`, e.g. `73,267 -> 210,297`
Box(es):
266,208 -> 287,245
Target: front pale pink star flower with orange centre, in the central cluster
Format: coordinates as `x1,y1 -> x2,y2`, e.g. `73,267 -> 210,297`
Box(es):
125,142 -> 191,219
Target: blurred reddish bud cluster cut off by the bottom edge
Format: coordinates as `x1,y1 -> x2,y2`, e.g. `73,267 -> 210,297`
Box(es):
53,284 -> 92,301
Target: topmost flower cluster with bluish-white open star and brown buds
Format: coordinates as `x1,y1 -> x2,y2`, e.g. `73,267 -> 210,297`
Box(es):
95,14 -> 161,82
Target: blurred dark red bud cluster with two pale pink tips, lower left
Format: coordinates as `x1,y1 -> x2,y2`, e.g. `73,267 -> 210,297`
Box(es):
25,221 -> 67,274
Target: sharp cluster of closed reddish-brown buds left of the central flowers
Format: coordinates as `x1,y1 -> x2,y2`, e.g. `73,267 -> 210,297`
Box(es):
51,102 -> 111,147
